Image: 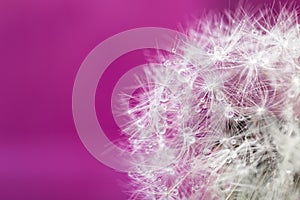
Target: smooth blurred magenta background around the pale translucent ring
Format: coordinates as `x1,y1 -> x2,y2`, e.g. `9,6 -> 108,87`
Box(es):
0,0 -> 294,200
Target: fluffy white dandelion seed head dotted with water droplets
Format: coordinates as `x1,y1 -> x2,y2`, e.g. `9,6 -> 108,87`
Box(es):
122,4 -> 300,200
